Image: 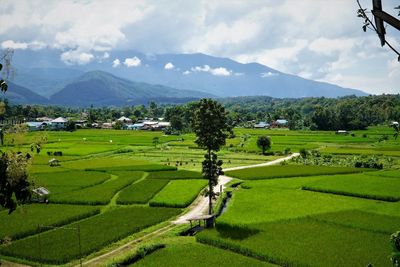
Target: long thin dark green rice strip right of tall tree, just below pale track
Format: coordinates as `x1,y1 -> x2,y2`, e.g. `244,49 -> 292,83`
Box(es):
226,165 -> 365,180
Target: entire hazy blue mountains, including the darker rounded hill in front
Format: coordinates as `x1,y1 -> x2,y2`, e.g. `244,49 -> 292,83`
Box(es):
3,49 -> 366,106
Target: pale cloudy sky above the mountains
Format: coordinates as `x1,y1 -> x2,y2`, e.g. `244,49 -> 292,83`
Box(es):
0,0 -> 400,94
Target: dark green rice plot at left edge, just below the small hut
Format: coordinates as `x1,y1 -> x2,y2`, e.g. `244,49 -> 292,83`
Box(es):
0,204 -> 100,243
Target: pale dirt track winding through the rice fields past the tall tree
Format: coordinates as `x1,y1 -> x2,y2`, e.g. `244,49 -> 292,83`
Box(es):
76,153 -> 300,267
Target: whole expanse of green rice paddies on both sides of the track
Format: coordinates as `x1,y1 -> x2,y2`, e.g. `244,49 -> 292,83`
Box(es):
0,126 -> 400,266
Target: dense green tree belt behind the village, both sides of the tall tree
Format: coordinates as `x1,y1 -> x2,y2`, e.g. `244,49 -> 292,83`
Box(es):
0,95 -> 400,131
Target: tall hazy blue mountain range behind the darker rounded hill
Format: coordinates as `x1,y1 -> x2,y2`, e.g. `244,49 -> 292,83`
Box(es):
9,49 -> 367,103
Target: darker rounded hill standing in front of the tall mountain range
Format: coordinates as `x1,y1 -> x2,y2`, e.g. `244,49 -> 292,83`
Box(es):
50,71 -> 212,106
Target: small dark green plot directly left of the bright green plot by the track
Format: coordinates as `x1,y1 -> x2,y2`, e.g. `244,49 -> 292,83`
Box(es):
117,179 -> 169,205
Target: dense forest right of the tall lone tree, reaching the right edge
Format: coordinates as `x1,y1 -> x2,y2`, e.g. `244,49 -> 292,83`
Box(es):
221,95 -> 400,130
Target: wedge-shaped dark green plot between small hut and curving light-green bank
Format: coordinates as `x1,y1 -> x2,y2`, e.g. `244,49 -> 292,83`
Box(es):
50,172 -> 144,205
